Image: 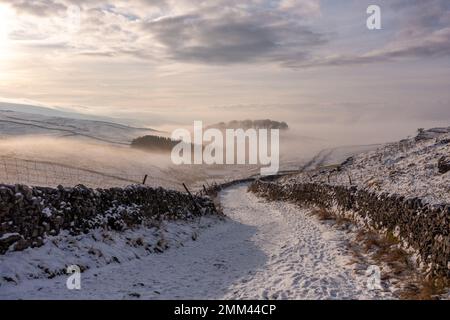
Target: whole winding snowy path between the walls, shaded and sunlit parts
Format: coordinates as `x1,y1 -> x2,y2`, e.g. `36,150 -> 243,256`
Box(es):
0,186 -> 386,299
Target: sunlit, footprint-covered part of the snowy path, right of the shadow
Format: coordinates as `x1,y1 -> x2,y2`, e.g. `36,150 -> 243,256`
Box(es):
222,186 -> 388,299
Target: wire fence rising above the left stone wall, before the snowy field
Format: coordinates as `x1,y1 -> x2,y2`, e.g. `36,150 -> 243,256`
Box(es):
0,157 -> 144,188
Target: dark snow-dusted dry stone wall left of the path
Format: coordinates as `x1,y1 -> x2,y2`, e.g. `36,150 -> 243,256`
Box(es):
0,185 -> 218,254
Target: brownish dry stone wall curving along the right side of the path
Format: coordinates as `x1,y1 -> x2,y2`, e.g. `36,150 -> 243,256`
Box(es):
249,181 -> 450,277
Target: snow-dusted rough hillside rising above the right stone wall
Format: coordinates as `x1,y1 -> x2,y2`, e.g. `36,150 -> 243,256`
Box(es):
286,127 -> 450,204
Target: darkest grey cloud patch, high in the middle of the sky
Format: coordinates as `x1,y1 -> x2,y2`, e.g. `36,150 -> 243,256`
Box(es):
144,13 -> 326,64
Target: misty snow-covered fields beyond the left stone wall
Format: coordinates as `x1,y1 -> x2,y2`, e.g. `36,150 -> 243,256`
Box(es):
0,102 -> 268,190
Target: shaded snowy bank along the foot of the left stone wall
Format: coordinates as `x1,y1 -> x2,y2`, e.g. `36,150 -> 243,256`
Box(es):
0,217 -> 219,288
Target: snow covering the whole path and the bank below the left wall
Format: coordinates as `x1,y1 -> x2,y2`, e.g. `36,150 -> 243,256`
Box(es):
0,185 -> 391,299
